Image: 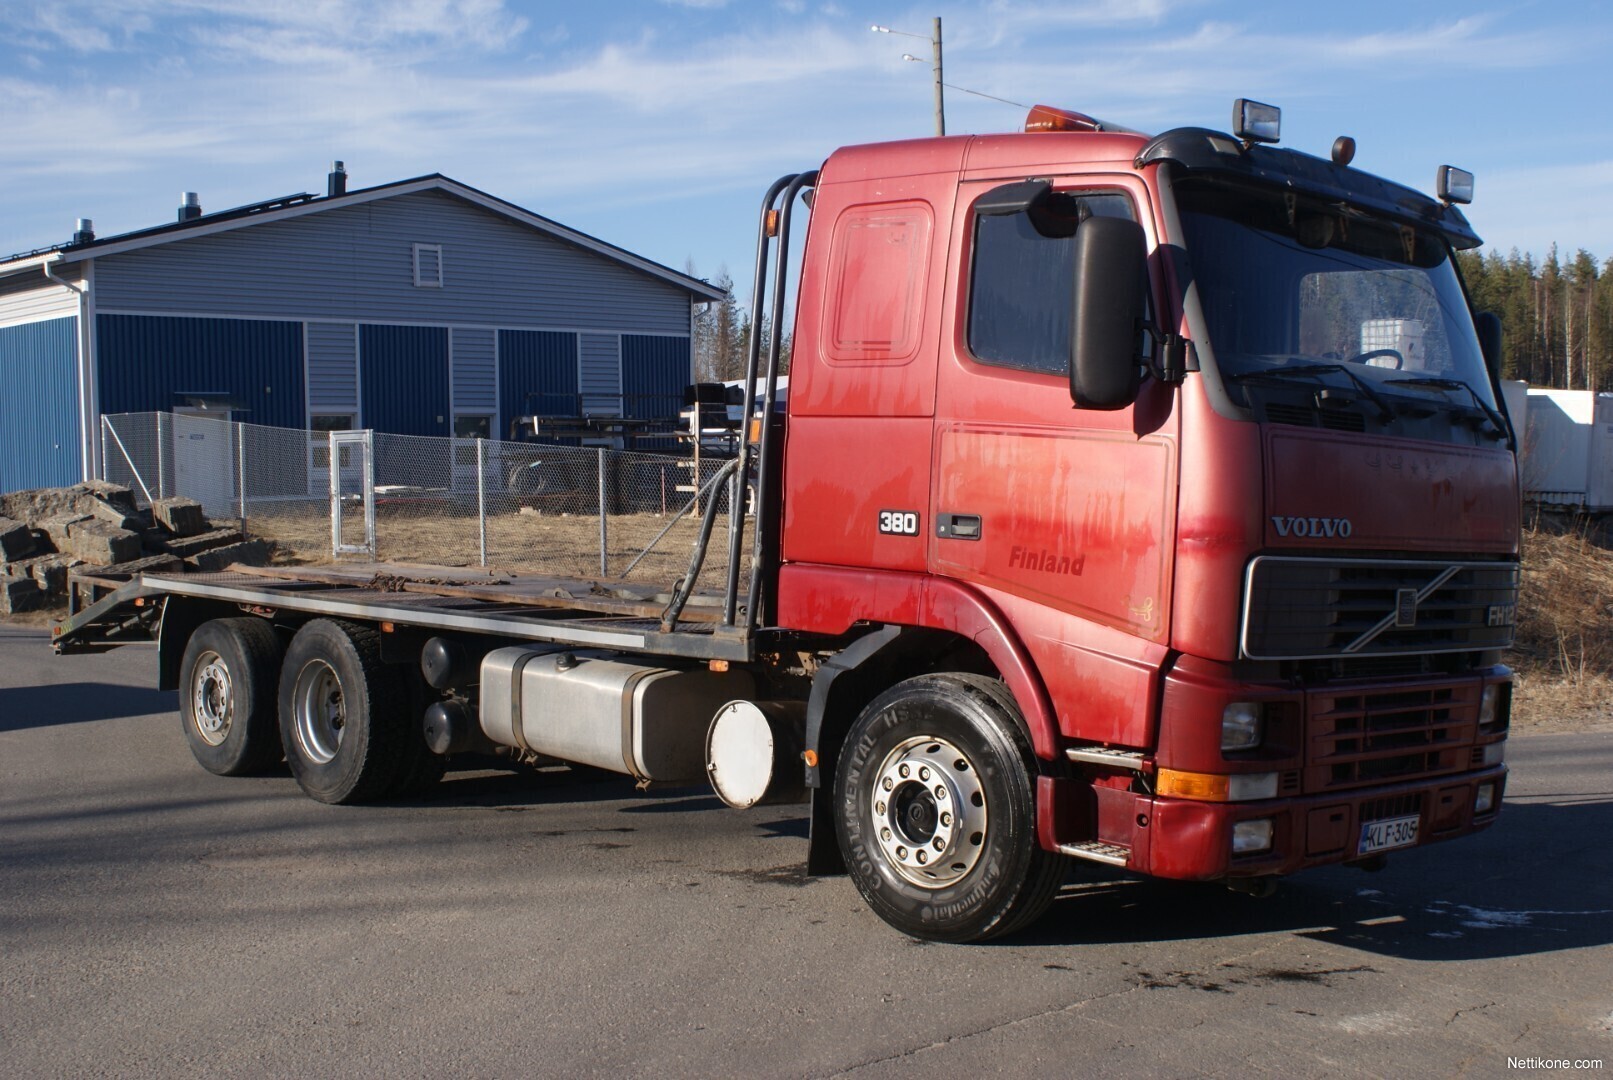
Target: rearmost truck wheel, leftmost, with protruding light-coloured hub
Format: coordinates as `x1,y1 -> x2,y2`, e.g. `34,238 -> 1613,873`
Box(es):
179,619 -> 282,777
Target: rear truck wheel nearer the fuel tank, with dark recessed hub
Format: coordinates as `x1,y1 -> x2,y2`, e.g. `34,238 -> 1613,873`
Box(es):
279,619 -> 403,803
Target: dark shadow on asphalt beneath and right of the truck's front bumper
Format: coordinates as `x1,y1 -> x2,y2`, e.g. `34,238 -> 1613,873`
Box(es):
1003,793 -> 1613,961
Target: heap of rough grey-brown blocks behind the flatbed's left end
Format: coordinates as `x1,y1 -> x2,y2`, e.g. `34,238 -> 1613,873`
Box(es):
0,480 -> 269,614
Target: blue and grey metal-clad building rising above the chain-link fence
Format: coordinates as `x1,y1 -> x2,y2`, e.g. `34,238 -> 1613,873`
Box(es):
0,163 -> 723,492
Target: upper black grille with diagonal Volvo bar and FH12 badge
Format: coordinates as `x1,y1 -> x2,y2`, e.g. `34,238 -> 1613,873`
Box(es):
1242,556 -> 1518,659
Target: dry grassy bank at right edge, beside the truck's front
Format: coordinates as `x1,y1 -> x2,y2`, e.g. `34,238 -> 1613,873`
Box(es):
1508,525 -> 1613,732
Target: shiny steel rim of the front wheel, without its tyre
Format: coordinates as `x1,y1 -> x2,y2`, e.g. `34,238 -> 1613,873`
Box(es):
868,735 -> 987,888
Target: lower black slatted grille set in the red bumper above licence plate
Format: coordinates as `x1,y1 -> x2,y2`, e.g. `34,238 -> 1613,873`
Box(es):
1305,682 -> 1479,796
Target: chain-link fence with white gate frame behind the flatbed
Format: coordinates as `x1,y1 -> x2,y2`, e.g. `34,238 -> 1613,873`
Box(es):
102,413 -> 750,587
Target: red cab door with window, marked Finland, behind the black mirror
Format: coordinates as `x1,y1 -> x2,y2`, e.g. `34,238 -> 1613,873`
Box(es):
929,176 -> 1177,745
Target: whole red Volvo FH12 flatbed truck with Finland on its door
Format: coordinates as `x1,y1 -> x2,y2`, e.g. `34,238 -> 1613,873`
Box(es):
55,102 -> 1519,941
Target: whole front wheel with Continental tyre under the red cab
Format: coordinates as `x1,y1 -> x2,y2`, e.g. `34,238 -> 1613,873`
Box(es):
834,674 -> 1066,941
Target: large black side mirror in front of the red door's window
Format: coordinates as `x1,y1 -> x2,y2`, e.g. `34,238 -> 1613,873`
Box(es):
1069,218 -> 1148,409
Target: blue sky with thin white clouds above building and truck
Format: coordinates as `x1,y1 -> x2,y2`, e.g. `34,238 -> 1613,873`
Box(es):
0,0 -> 1613,304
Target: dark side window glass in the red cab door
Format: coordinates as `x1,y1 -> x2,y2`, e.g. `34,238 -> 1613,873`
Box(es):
968,193 -> 1137,376
